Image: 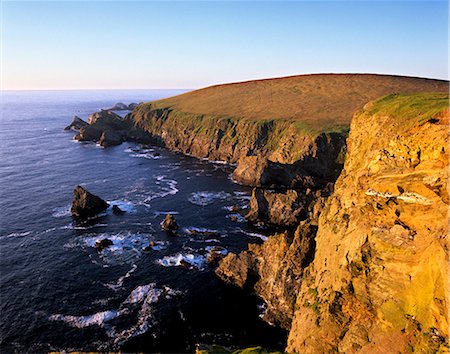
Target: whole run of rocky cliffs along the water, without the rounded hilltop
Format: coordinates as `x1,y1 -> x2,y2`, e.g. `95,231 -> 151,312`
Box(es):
69,81 -> 448,353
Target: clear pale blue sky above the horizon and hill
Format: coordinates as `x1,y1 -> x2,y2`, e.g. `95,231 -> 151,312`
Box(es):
2,0 -> 448,89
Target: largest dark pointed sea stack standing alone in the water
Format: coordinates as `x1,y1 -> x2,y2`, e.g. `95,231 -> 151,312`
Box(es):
70,186 -> 108,218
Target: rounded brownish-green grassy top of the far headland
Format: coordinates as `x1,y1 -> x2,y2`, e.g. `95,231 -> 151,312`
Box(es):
144,74 -> 448,131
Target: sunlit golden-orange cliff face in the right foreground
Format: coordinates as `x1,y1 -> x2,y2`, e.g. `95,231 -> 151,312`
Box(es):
287,94 -> 449,353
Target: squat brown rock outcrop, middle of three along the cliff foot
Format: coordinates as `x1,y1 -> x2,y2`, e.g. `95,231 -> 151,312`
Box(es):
245,188 -> 306,227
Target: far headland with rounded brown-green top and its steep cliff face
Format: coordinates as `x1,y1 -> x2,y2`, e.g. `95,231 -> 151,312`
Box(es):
126,74 -> 448,188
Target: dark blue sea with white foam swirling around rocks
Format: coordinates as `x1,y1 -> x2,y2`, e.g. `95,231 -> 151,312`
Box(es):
0,90 -> 285,353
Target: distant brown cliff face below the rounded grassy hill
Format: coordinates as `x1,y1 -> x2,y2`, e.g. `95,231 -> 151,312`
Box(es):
128,103 -> 346,164
